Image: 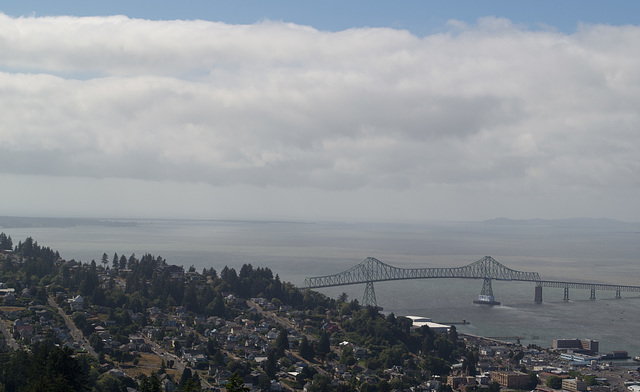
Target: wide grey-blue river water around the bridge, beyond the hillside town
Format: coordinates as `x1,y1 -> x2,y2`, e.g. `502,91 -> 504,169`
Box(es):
2,220 -> 640,355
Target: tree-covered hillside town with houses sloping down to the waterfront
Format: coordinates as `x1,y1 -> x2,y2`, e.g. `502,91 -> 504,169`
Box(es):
0,233 -> 640,392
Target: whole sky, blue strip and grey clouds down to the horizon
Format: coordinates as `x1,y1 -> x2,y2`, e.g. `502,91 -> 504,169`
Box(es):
0,0 -> 640,222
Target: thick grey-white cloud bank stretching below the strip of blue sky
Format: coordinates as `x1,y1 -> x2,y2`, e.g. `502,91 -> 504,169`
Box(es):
0,14 -> 640,217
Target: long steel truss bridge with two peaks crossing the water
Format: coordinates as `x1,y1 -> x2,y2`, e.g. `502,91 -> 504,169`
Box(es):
304,256 -> 640,306
